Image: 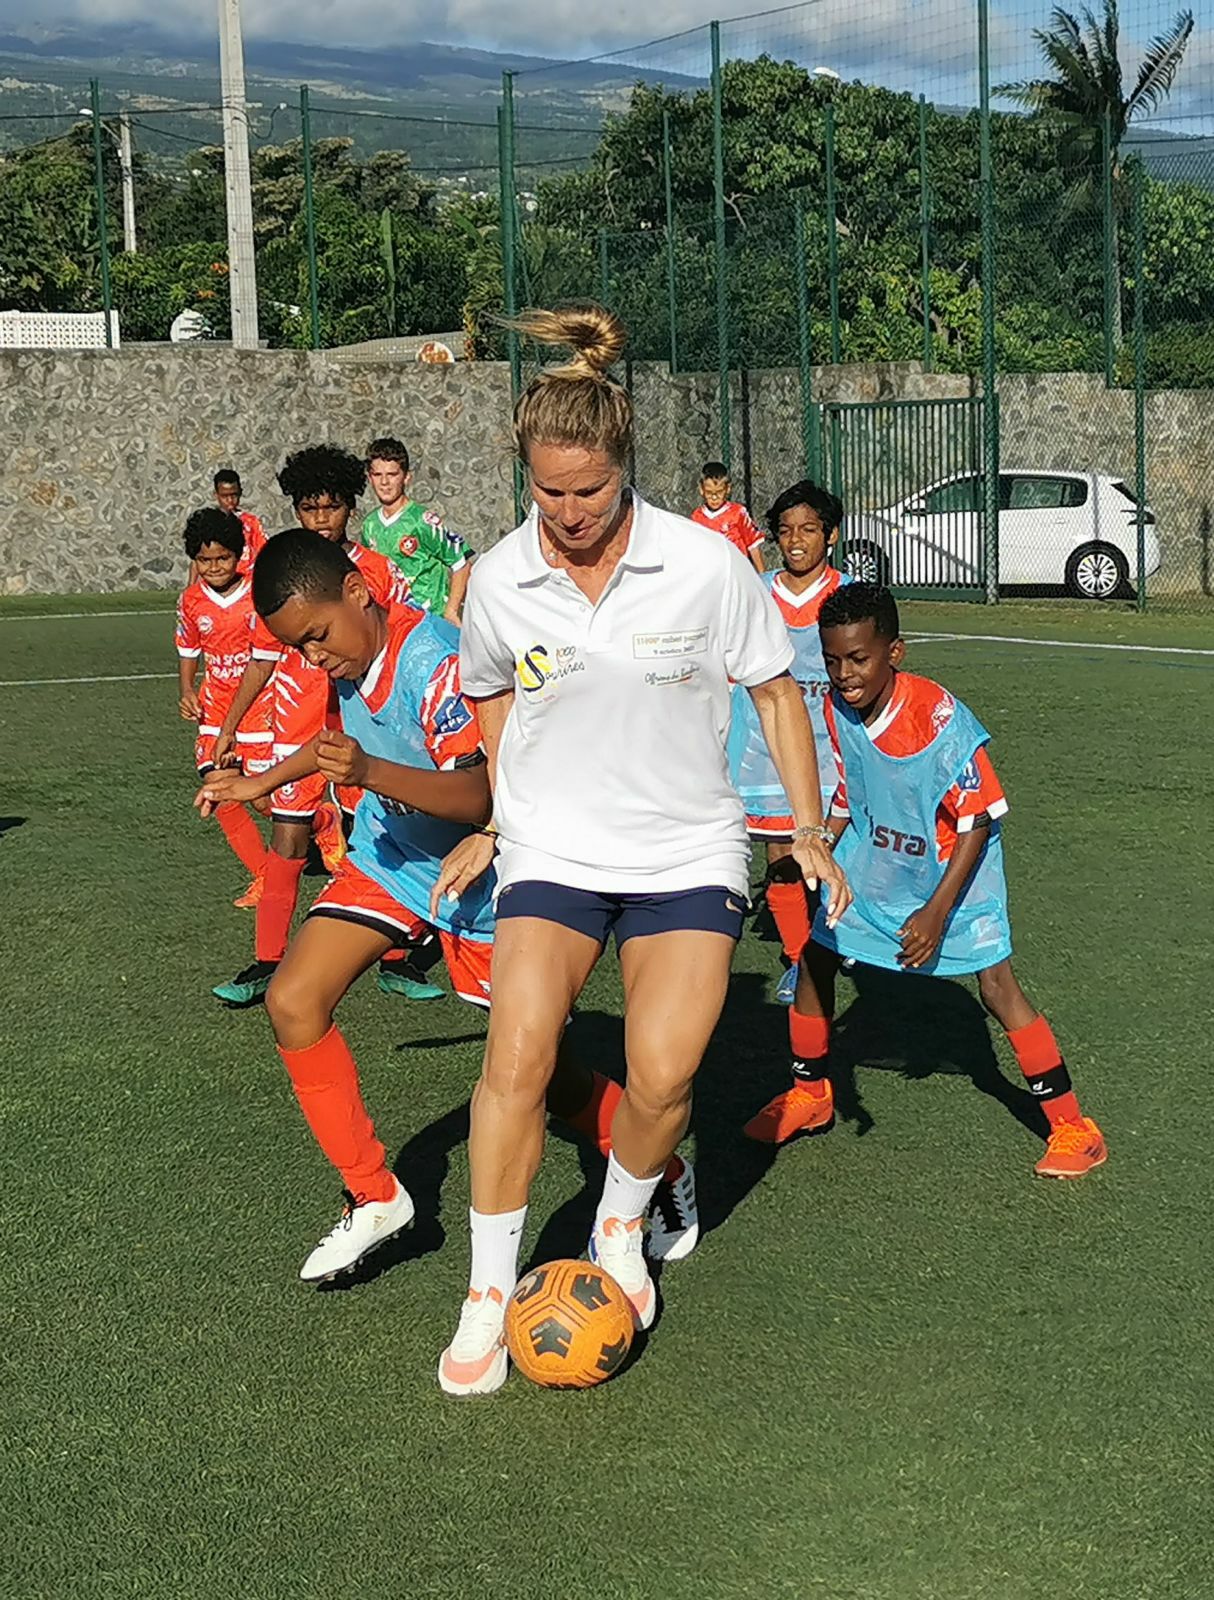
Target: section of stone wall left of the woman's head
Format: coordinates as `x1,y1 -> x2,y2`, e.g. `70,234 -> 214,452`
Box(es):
0,346 -> 513,594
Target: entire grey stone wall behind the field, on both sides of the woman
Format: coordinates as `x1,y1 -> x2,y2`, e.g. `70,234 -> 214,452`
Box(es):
0,346 -> 1214,594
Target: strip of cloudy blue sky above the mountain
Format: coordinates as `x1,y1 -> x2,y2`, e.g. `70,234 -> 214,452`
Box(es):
11,0 -> 1214,110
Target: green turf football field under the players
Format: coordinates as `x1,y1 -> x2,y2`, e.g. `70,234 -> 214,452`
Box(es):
0,597 -> 1214,1600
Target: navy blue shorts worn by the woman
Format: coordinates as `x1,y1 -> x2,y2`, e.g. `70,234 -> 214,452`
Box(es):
497,878 -> 749,949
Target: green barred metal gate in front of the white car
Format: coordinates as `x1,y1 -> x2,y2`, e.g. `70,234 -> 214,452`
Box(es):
821,398 -> 996,600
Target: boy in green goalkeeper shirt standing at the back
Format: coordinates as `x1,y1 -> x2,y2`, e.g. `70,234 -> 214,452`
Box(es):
358,438 -> 475,627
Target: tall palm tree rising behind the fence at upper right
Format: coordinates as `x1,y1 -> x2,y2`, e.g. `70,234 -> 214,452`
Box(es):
995,0 -> 1193,344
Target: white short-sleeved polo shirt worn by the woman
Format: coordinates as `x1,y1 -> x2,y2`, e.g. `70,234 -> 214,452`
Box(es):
459,493 -> 793,894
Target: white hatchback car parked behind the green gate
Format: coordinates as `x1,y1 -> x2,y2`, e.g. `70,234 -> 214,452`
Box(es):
846,467 -> 1160,600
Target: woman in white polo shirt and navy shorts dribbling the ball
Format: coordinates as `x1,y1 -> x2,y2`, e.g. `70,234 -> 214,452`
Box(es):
438,307 -> 849,1394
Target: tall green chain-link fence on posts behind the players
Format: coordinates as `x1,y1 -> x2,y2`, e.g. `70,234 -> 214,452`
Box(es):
0,0 -> 1214,605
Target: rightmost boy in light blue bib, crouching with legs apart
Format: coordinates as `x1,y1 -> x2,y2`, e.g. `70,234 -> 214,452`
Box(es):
745,584 -> 1108,1178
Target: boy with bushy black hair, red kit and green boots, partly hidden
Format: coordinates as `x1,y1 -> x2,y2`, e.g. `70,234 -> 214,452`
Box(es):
213,445 -> 408,1006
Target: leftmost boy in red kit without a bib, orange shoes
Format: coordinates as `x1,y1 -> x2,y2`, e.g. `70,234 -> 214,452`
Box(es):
176,507 -> 270,907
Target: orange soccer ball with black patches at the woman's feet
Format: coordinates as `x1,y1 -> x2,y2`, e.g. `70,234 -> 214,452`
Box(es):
505,1261 -> 633,1389
